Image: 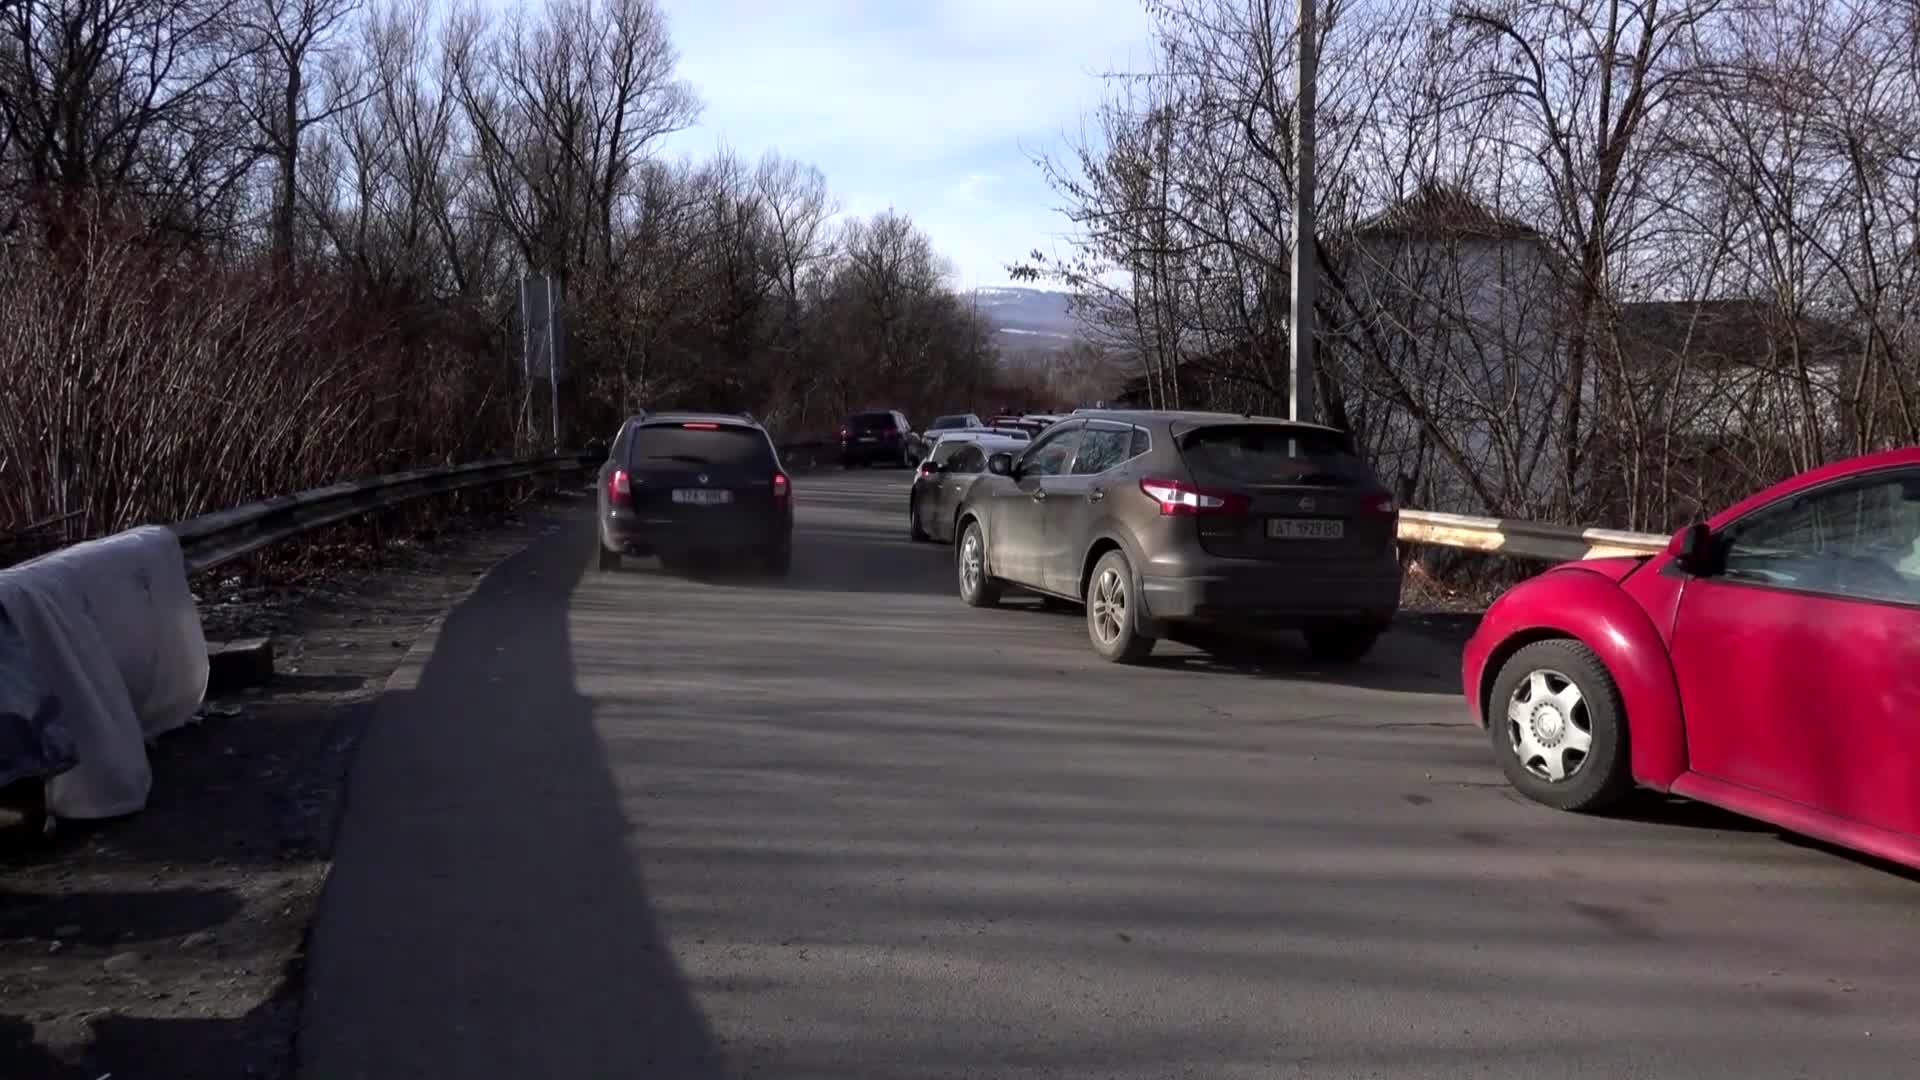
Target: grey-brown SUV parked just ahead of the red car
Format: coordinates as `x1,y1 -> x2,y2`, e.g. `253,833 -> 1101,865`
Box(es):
954,409 -> 1400,663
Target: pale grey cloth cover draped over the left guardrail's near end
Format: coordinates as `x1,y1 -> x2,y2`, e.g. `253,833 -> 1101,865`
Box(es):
0,527 -> 207,819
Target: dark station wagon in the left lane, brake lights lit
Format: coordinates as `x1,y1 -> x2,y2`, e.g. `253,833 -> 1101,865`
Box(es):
597,413 -> 793,575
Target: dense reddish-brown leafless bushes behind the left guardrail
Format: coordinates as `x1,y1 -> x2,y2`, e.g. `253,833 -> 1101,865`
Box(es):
0,203 -> 511,538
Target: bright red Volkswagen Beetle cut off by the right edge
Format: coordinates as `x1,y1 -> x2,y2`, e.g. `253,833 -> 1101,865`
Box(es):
1461,448 -> 1920,869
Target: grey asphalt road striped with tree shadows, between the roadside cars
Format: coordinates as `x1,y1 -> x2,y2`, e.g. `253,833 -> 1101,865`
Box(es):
300,471 -> 1920,1080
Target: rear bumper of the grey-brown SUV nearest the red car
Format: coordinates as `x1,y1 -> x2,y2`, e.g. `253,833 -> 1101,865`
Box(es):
1140,559 -> 1400,625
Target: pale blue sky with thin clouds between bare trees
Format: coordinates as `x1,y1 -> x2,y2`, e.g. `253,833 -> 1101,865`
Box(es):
660,0 -> 1150,288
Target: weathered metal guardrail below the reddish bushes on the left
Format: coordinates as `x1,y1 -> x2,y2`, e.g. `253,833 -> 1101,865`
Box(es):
169,452 -> 605,575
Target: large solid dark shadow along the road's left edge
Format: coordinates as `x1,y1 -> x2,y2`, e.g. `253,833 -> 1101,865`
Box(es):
298,517 -> 720,1080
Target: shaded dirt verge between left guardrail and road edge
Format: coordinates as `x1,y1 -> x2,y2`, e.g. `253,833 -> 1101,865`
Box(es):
0,496 -> 586,1080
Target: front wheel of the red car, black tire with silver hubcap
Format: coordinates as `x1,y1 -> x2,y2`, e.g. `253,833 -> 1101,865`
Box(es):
1486,638 -> 1634,813
